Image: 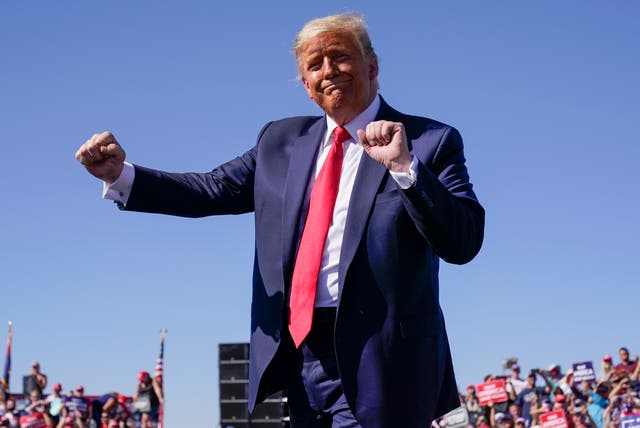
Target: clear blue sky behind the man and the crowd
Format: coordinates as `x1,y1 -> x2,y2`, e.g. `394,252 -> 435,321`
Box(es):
0,0 -> 640,427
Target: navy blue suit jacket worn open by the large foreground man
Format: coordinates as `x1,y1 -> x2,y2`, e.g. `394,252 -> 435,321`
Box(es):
126,100 -> 484,428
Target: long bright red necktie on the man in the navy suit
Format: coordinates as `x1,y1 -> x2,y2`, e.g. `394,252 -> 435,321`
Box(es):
289,126 -> 349,348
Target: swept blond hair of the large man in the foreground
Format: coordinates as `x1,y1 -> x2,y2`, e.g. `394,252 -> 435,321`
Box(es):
293,13 -> 377,76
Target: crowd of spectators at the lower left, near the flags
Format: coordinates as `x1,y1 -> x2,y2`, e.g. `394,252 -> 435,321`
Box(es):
0,362 -> 164,428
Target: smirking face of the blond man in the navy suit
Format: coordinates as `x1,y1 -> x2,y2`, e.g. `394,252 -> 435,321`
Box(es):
298,33 -> 378,125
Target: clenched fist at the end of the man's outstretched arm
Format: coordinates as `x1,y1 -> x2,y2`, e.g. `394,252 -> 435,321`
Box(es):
76,131 -> 126,184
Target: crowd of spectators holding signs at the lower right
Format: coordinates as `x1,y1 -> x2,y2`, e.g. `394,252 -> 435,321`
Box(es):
456,347 -> 640,428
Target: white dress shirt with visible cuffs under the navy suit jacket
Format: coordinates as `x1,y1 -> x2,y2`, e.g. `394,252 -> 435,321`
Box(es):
102,96 -> 417,307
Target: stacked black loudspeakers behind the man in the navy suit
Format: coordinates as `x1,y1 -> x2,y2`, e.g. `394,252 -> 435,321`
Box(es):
218,343 -> 289,428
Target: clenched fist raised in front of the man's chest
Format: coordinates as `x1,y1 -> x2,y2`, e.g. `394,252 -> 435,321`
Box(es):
358,120 -> 411,172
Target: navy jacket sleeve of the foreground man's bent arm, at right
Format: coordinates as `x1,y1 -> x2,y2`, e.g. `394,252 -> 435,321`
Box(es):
402,127 -> 485,264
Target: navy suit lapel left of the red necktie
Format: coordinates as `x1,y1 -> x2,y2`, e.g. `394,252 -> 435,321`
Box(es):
282,116 -> 327,284
